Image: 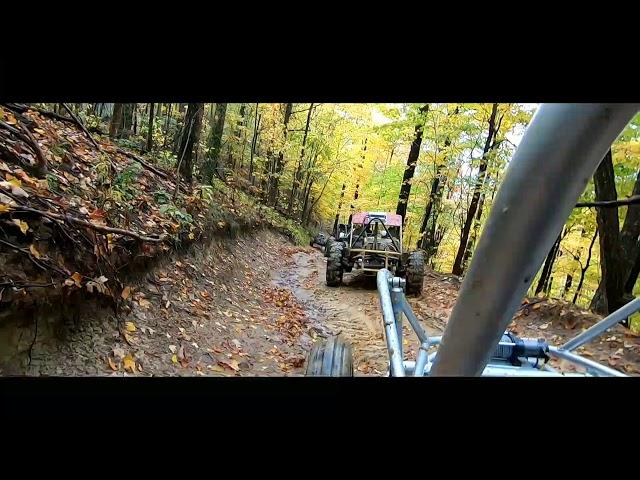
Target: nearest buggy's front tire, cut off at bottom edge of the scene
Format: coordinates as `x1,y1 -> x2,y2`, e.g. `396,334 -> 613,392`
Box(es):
305,337 -> 353,377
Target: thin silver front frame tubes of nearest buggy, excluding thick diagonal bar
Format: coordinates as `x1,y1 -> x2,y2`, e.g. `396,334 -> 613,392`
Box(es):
377,269 -> 628,377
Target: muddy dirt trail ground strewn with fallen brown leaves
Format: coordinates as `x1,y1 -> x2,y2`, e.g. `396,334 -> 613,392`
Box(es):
8,230 -> 640,376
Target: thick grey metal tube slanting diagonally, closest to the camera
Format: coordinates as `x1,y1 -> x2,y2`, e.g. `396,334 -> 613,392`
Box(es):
431,103 -> 640,376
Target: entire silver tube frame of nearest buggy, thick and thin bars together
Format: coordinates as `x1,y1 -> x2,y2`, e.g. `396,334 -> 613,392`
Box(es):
377,103 -> 640,376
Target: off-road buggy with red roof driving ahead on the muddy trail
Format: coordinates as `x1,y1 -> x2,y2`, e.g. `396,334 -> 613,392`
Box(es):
325,212 -> 424,294
